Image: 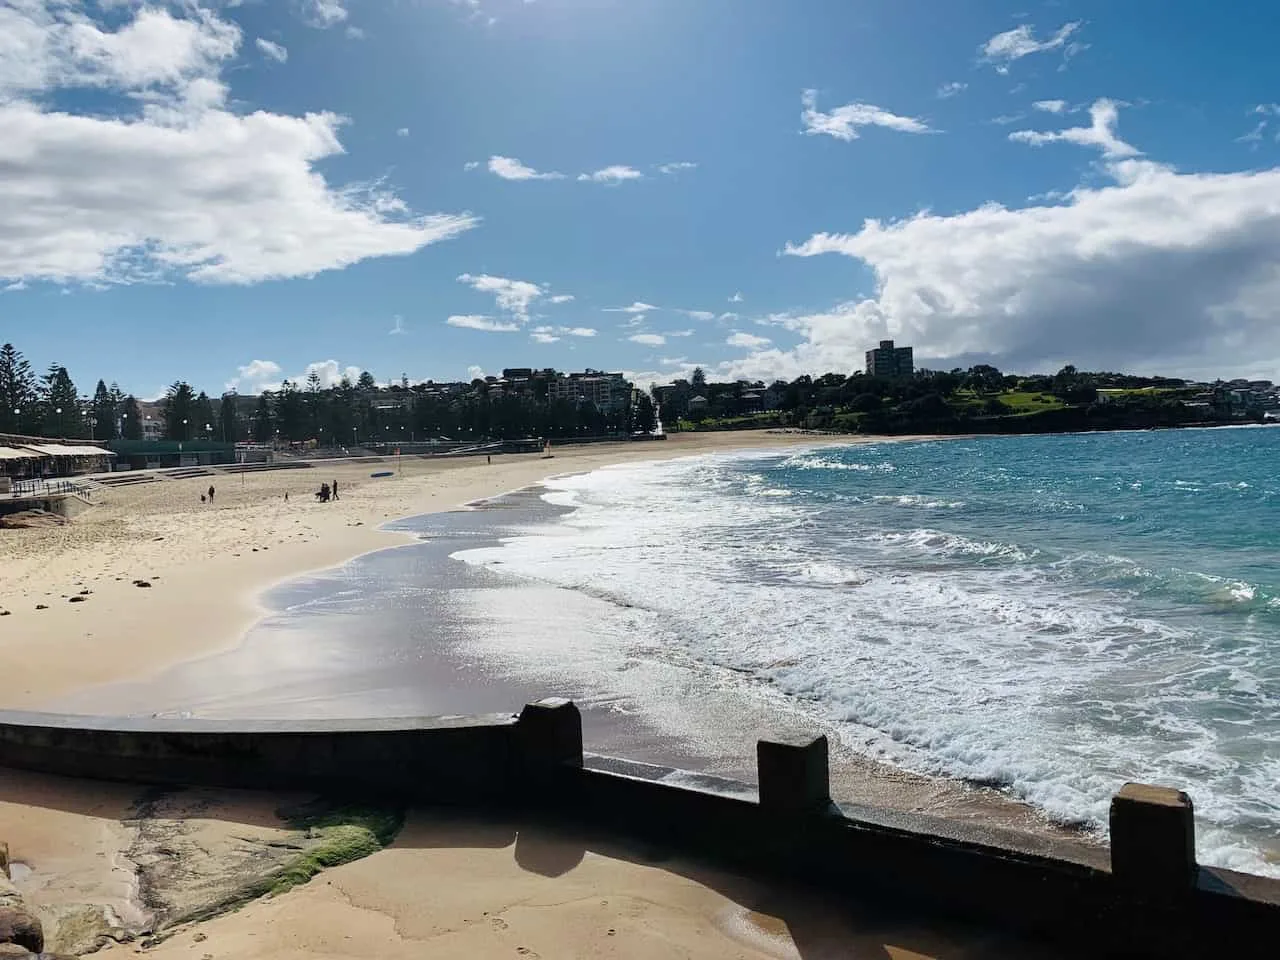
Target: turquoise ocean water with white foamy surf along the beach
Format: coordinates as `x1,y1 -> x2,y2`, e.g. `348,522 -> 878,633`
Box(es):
453,429 -> 1280,876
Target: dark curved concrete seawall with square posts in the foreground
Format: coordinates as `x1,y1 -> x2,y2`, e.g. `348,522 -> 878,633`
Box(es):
0,700 -> 1280,956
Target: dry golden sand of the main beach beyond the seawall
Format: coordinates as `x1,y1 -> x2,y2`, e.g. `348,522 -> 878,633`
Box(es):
0,433 -> 860,709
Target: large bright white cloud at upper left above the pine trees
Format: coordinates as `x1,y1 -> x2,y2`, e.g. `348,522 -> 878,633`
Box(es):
0,3 -> 476,284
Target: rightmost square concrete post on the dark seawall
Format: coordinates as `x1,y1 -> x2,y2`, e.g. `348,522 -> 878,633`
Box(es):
1111,783 -> 1196,896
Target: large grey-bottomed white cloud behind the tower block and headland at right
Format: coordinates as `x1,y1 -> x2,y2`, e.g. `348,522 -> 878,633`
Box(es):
773,129 -> 1280,376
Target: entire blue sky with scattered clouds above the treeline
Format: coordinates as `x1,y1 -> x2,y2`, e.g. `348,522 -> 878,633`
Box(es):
0,0 -> 1280,396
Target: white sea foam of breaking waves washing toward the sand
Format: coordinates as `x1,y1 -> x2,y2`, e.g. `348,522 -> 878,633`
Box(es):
457,453 -> 1280,876
